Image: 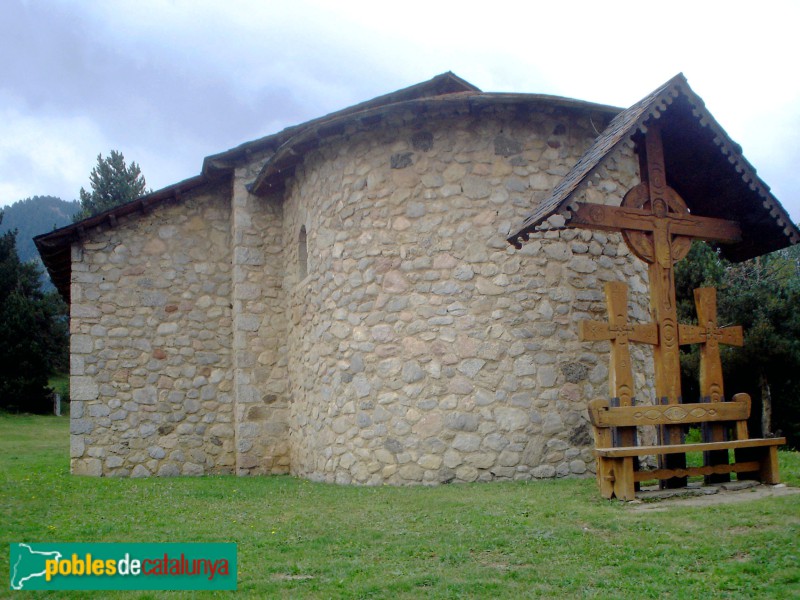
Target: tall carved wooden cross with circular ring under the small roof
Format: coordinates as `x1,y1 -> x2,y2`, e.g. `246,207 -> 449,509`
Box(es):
570,123 -> 742,485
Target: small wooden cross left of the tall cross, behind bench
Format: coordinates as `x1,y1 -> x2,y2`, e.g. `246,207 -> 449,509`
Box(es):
578,281 -> 658,446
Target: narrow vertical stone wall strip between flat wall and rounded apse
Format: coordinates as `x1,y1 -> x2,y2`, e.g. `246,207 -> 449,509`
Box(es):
231,158 -> 289,475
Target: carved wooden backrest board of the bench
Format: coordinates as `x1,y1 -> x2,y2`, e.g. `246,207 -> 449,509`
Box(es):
589,394 -> 750,439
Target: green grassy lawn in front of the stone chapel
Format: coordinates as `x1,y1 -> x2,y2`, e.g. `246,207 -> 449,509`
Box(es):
0,416 -> 800,598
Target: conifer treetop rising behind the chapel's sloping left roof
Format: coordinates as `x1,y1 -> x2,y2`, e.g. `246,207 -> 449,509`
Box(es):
73,150 -> 148,222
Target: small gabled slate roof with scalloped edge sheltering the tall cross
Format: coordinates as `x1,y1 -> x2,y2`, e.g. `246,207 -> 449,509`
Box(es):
508,74 -> 800,261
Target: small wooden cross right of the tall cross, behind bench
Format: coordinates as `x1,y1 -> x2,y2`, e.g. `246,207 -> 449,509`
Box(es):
678,288 -> 744,483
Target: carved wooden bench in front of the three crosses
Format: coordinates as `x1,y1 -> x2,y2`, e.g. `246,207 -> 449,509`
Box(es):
589,394 -> 786,500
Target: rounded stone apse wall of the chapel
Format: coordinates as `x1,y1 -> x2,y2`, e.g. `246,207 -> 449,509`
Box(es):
283,106 -> 652,484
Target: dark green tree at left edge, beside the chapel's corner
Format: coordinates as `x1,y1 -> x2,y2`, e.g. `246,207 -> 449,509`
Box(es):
0,213 -> 67,413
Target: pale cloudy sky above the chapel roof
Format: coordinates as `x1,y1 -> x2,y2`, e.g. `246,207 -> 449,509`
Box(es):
0,0 -> 800,222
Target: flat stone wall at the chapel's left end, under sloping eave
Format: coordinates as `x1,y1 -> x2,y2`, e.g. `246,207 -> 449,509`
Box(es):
70,182 -> 236,477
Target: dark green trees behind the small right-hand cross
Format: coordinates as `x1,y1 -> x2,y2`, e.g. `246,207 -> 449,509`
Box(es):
675,242 -> 800,446
